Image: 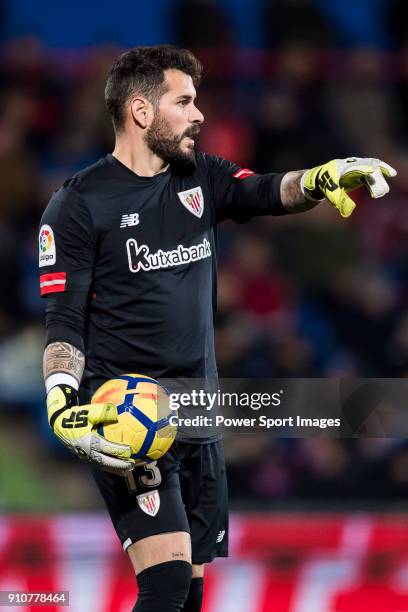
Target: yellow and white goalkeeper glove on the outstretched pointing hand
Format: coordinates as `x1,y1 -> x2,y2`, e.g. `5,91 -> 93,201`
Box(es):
300,157 -> 397,217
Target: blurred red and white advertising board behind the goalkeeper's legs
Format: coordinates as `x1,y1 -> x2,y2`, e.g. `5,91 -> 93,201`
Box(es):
0,514 -> 408,612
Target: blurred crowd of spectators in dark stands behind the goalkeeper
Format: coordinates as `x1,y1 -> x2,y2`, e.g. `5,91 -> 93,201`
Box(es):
0,0 -> 408,507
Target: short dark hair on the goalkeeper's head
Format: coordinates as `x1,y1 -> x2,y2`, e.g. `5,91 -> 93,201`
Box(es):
105,45 -> 203,131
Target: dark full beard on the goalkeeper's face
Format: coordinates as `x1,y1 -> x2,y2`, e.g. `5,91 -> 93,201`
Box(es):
145,112 -> 200,169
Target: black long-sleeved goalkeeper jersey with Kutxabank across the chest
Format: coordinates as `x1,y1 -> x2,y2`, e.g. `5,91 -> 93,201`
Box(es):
39,154 -> 286,438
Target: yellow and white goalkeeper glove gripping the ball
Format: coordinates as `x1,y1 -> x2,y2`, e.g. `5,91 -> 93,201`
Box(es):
47,385 -> 134,475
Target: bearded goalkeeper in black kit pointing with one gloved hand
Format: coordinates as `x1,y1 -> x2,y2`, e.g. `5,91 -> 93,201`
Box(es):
39,46 -> 396,612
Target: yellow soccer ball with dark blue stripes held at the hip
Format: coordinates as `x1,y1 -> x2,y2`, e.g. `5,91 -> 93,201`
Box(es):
91,374 -> 177,465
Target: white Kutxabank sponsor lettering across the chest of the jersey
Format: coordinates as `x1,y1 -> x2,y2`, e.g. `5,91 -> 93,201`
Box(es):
126,238 -> 211,272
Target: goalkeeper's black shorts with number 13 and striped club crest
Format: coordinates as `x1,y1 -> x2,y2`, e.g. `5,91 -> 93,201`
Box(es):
92,441 -> 228,564
